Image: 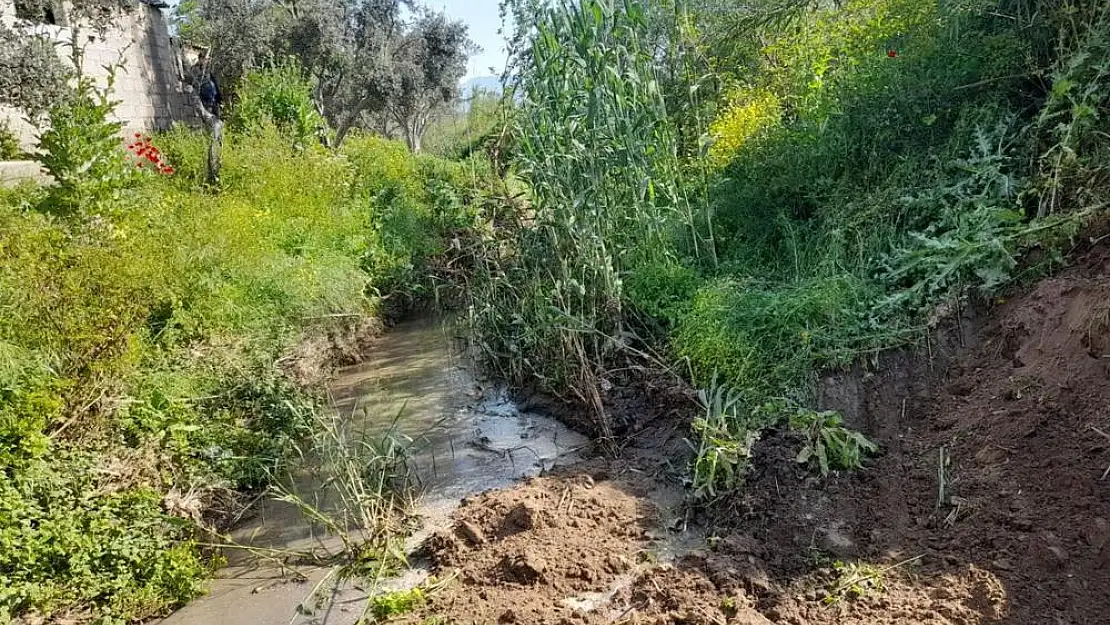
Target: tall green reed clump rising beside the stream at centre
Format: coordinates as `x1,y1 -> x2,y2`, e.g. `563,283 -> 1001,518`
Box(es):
473,0 -> 710,437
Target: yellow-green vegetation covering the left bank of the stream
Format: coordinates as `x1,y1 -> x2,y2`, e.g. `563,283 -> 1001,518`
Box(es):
0,58 -> 488,623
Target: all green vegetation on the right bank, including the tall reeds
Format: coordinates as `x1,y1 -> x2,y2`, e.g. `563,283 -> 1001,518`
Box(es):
472,0 -> 1110,500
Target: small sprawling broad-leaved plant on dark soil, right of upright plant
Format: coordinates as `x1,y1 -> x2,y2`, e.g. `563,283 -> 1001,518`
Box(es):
790,410 -> 879,476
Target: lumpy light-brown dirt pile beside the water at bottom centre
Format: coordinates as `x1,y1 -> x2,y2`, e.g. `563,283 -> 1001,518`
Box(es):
412,474 -> 655,624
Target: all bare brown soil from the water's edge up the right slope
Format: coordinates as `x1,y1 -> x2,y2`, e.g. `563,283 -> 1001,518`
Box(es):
395,240 -> 1110,625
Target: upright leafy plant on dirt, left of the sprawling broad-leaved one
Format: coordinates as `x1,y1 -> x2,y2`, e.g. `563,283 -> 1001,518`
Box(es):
687,380 -> 759,498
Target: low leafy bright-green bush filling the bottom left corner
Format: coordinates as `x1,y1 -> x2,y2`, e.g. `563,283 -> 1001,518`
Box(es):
0,447 -> 206,621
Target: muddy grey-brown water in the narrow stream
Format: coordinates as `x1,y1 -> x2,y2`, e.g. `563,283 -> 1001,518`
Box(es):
163,320 -> 586,625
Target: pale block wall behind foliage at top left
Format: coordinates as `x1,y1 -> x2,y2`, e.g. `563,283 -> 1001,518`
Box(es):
0,0 -> 190,148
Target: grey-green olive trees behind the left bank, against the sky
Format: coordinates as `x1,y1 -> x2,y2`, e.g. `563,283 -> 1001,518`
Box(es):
178,0 -> 474,149
